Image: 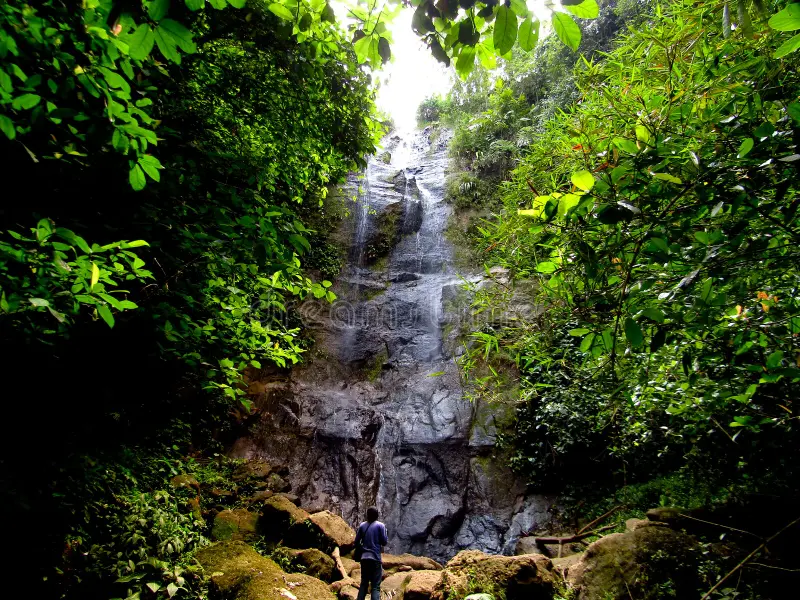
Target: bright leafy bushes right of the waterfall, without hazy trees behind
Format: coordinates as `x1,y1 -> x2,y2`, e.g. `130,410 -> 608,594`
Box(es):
456,3 -> 800,496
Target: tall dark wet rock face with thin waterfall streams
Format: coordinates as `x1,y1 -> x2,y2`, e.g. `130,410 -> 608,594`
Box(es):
233,132 -> 551,561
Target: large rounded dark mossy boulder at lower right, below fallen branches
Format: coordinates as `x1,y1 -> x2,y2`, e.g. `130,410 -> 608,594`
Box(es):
567,524 -> 700,600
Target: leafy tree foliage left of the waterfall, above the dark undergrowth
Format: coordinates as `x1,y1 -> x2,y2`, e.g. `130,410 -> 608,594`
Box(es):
0,2 -> 382,406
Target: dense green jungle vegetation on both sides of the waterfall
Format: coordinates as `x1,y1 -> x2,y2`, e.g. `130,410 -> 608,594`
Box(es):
0,0 -> 800,599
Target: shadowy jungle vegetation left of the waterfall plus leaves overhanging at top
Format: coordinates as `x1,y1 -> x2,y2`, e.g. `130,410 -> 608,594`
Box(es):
0,0 -> 595,598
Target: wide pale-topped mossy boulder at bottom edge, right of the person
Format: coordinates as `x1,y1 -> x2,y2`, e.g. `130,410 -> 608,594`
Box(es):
431,550 -> 557,600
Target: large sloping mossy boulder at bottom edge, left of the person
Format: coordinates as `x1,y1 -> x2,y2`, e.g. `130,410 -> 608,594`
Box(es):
197,542 -> 335,600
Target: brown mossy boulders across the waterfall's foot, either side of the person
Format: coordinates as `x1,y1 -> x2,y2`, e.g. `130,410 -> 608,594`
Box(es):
180,461 -> 699,600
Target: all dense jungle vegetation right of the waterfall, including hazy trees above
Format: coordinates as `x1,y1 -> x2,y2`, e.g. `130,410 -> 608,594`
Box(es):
434,1 -> 800,536
